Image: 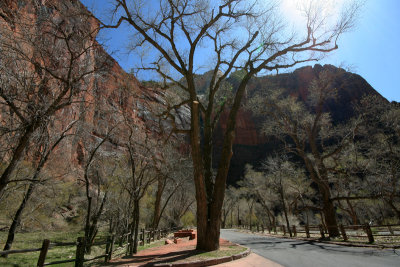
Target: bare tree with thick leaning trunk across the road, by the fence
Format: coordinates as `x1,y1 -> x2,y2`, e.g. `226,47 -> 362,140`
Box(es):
253,70 -> 358,237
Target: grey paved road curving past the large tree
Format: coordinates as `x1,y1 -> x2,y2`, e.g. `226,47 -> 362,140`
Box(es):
221,229 -> 400,267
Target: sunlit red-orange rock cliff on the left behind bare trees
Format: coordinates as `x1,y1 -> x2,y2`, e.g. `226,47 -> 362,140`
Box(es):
0,0 -> 170,176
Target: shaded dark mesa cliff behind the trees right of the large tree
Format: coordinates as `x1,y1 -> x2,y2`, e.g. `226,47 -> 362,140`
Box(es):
214,64 -> 379,184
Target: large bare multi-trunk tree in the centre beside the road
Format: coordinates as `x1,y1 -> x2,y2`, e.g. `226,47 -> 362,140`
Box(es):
100,0 -> 358,251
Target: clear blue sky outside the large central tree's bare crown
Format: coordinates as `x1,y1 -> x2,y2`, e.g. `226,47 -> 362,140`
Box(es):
81,0 -> 400,102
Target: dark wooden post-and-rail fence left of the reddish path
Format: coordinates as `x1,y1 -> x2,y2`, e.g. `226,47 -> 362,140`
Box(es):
0,228 -> 179,267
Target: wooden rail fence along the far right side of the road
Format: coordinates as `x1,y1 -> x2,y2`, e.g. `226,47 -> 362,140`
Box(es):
234,224 -> 400,245
